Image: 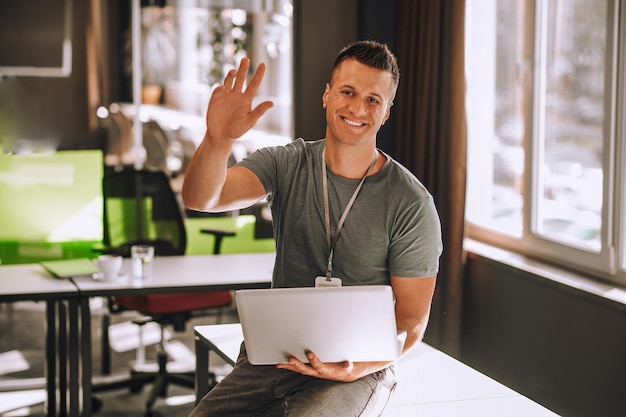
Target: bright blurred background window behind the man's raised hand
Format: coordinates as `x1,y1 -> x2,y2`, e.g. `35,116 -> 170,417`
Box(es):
129,0 -> 293,139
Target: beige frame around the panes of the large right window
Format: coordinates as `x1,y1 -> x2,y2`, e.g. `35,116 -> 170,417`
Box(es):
466,0 -> 626,285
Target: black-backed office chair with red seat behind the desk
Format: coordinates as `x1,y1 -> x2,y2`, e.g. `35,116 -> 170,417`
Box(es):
93,168 -> 234,416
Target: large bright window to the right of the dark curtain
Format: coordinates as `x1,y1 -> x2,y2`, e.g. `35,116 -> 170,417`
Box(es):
466,0 -> 626,284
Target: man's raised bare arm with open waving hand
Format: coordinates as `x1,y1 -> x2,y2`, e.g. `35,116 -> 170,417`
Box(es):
182,58 -> 273,212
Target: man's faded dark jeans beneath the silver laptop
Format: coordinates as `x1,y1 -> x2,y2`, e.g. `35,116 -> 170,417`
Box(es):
190,344 -> 396,417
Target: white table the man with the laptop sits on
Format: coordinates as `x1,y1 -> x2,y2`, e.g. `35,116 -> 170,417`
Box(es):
194,323 -> 557,417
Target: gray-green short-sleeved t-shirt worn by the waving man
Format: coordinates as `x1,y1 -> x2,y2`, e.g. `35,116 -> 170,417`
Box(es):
239,139 -> 443,287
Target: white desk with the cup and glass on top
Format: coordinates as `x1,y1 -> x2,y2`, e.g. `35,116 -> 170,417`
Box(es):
73,253 -> 275,416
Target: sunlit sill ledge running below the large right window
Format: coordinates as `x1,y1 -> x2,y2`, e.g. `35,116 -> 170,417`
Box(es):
463,239 -> 626,310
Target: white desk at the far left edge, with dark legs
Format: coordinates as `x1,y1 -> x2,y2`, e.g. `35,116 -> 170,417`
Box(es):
0,264 -> 80,416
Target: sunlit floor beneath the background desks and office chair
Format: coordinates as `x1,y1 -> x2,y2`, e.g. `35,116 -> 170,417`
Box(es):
0,299 -> 237,417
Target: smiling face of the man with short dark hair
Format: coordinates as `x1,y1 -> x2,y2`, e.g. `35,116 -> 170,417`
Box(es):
322,59 -> 395,144
